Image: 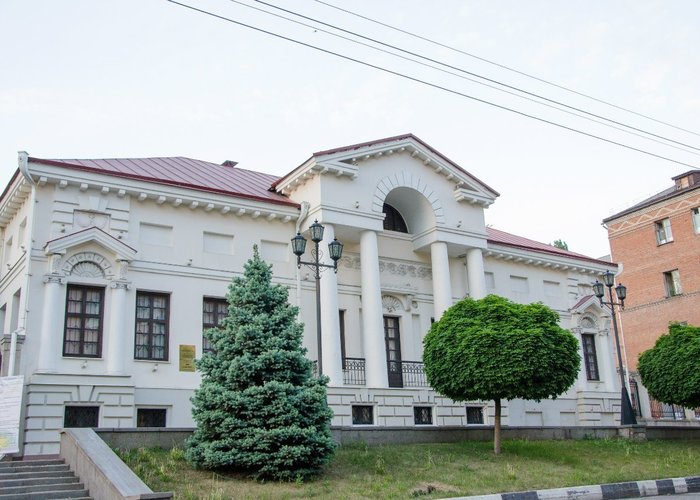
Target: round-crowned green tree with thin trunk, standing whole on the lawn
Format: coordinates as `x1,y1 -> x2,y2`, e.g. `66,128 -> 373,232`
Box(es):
423,295 -> 581,454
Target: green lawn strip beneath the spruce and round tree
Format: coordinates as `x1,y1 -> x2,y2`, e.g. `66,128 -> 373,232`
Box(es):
118,439 -> 700,500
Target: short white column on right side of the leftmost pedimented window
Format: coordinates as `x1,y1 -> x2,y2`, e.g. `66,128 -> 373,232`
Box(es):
102,281 -> 134,375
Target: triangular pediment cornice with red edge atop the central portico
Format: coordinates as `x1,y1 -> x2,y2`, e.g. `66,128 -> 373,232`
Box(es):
273,134 -> 499,207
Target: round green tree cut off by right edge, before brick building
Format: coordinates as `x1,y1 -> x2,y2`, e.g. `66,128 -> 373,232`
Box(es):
637,323 -> 700,408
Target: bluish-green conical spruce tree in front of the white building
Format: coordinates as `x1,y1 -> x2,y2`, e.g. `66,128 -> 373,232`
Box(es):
186,246 -> 335,480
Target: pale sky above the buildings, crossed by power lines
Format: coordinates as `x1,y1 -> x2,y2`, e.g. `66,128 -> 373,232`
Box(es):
0,0 -> 700,257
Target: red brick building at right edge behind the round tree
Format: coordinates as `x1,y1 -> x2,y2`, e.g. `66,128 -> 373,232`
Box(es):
603,170 -> 700,420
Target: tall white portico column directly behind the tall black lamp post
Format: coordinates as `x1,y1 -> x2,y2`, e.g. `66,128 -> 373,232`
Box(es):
321,224 -> 343,386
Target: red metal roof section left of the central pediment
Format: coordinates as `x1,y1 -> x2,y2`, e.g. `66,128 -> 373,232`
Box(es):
29,156 -> 298,206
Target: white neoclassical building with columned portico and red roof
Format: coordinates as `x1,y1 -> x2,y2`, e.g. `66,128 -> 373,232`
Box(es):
0,134 -> 619,455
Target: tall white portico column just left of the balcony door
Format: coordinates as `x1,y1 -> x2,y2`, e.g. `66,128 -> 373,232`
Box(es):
360,231 -> 389,388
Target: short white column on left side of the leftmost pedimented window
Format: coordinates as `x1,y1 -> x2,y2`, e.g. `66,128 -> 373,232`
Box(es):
38,273 -> 65,372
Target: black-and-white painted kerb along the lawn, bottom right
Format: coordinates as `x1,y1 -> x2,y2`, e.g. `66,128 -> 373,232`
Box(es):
452,476 -> 700,500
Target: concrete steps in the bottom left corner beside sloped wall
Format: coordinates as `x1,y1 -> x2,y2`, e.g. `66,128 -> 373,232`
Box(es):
0,459 -> 92,500
